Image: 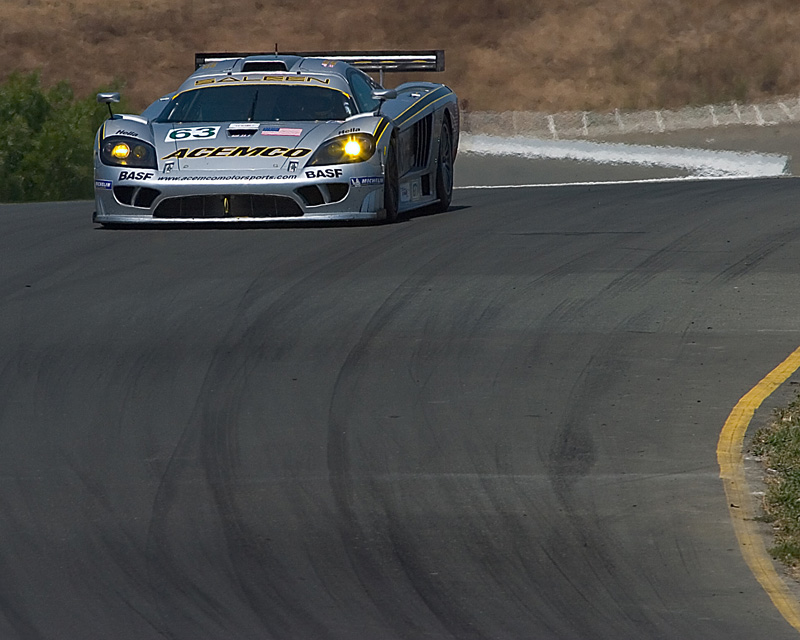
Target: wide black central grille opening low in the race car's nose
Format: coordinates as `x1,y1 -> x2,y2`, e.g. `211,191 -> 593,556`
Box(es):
153,195 -> 303,219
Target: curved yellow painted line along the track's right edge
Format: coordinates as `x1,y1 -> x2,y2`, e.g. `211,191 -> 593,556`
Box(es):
717,347 -> 800,631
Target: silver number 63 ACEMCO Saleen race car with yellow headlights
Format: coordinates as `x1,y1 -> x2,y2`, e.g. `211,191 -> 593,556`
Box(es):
94,51 -> 459,225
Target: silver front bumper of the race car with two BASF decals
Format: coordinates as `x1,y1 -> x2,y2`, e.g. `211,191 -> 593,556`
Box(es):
93,163 -> 385,225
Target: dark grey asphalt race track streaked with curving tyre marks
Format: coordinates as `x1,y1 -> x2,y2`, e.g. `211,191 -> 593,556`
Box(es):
0,178 -> 800,640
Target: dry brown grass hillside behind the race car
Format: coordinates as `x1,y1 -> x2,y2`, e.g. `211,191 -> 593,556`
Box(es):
0,0 -> 800,111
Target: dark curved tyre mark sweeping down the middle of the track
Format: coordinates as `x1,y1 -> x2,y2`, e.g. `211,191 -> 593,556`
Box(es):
327,238 -> 482,640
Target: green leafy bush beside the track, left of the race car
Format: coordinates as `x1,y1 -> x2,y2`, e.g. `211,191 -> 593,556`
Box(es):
0,73 -> 120,202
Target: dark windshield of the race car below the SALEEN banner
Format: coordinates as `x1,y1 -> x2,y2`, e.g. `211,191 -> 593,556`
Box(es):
156,85 -> 355,122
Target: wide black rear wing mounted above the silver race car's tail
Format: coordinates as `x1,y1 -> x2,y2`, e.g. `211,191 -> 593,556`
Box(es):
194,49 -> 444,74
